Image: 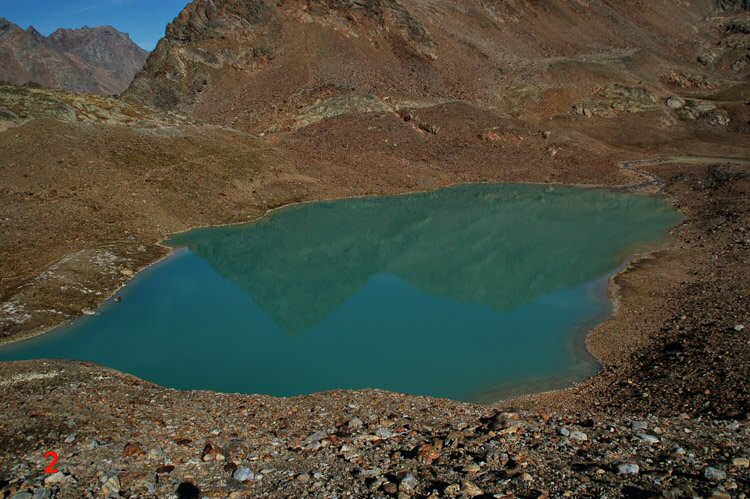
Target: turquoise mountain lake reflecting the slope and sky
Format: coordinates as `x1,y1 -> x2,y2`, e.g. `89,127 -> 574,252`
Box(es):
0,185 -> 681,401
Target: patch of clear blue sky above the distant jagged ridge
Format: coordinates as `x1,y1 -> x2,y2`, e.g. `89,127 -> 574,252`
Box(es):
0,0 -> 190,50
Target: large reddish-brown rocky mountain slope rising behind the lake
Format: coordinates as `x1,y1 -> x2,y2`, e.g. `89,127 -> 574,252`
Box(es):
127,0 -> 743,132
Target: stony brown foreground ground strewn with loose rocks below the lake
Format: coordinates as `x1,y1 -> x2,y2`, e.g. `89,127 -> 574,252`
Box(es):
2,362 -> 750,498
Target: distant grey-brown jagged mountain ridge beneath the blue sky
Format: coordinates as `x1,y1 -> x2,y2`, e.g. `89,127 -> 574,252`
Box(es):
0,19 -> 148,95
